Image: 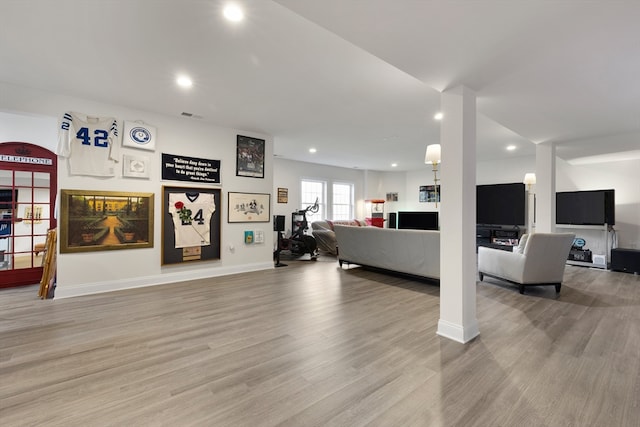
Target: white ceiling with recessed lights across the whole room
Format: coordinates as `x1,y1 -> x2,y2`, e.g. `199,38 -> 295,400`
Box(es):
0,0 -> 640,170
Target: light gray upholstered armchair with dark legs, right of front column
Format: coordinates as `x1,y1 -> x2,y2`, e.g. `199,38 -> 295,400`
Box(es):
478,233 -> 575,294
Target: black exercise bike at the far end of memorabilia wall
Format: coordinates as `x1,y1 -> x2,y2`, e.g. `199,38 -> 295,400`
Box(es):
274,199 -> 320,267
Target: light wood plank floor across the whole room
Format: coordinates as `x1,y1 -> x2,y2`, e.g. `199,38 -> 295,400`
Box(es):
0,258 -> 640,427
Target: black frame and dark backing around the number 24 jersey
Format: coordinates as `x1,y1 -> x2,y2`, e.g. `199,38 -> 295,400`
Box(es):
162,186 -> 223,265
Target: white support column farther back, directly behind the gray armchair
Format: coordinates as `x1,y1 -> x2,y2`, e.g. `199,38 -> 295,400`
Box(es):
536,143 -> 556,233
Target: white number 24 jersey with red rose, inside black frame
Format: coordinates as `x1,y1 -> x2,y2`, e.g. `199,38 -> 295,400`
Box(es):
169,193 -> 216,248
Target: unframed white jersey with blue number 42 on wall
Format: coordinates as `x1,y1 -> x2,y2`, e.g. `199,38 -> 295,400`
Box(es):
57,113 -> 118,176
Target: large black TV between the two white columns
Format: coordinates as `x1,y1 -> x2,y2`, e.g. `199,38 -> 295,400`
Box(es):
476,182 -> 527,226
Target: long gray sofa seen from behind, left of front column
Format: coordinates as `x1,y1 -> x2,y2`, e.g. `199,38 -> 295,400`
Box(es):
334,224 -> 440,280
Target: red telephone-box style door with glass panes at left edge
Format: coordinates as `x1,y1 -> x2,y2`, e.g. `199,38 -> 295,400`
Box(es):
0,142 -> 58,288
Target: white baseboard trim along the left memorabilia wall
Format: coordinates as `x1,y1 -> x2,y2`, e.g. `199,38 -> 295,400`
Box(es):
54,262 -> 274,299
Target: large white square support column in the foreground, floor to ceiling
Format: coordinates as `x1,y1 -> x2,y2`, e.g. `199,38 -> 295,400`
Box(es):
437,86 -> 480,343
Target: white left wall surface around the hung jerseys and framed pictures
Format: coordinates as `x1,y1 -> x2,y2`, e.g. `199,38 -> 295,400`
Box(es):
0,83 -> 274,297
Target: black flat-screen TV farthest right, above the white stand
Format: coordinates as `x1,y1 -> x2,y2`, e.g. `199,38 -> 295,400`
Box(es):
556,190 -> 616,225
